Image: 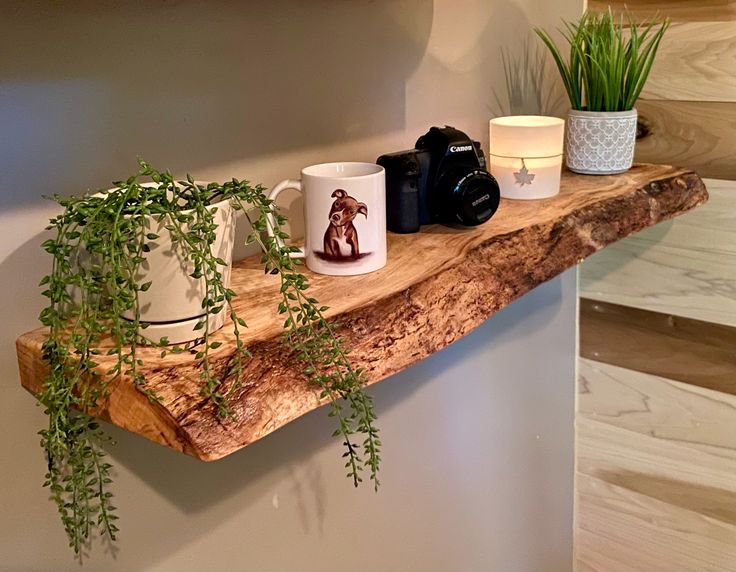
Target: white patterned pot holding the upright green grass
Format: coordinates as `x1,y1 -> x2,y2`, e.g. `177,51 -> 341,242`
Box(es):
565,109 -> 637,175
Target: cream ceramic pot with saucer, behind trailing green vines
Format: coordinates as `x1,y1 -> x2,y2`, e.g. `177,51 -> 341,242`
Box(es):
123,189 -> 235,344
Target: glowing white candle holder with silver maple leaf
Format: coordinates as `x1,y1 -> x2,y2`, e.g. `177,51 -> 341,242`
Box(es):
490,115 -> 565,199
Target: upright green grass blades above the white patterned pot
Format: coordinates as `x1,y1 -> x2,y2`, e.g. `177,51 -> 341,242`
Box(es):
535,7 -> 670,111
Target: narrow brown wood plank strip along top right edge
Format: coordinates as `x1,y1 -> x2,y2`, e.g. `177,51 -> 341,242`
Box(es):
588,0 -> 736,22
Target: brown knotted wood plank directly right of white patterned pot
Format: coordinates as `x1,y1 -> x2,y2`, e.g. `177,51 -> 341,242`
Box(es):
636,99 -> 736,179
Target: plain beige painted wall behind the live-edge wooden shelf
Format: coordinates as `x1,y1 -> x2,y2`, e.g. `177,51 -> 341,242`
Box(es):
0,0 -> 580,572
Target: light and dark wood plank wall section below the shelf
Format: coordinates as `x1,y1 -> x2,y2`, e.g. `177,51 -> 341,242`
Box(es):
575,180 -> 736,572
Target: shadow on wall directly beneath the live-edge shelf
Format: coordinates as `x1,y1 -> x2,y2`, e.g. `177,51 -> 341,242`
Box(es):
108,268 -> 562,513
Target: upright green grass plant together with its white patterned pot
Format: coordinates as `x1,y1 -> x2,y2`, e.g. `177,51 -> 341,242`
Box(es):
535,7 -> 669,175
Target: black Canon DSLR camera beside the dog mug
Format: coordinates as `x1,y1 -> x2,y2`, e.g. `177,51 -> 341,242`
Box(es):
376,126 -> 500,233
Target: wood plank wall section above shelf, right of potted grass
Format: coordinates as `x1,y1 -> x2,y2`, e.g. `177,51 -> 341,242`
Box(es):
588,0 -> 736,180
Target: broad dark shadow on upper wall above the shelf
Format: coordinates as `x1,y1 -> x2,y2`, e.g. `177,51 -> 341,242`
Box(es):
0,0 -> 432,208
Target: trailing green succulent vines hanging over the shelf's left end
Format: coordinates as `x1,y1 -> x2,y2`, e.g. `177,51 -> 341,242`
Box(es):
39,160 -> 381,553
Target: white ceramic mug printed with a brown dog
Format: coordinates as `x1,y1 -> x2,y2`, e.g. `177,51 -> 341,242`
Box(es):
268,163 -> 386,276
